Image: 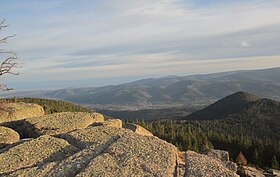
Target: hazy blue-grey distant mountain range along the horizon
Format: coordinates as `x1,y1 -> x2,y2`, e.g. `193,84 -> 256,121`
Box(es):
1,68 -> 280,105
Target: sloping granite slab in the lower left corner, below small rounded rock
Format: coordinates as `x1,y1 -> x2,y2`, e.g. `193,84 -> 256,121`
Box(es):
0,135 -> 77,176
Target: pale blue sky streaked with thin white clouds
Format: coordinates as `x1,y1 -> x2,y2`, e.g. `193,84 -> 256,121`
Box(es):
0,0 -> 280,90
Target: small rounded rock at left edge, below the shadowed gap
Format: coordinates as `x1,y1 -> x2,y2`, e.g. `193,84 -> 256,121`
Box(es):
0,126 -> 20,148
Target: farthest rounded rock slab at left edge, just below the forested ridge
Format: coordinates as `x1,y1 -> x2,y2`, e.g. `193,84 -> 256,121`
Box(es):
0,103 -> 45,123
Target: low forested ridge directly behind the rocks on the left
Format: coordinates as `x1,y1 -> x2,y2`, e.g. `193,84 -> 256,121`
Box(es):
0,98 -> 90,114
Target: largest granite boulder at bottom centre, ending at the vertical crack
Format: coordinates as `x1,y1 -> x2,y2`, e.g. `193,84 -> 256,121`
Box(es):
59,126 -> 177,176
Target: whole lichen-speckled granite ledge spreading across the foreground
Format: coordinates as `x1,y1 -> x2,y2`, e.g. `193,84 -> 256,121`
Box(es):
0,101 -> 245,177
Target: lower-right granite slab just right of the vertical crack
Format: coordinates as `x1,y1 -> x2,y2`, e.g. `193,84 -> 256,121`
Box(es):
185,151 -> 238,177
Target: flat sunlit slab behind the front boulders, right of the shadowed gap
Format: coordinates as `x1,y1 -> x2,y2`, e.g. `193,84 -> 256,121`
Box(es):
22,112 -> 94,137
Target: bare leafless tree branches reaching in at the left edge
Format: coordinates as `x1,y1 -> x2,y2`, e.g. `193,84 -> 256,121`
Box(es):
0,20 -> 18,91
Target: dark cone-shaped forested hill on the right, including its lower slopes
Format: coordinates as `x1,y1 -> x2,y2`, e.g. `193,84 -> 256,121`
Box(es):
186,92 -> 280,140
